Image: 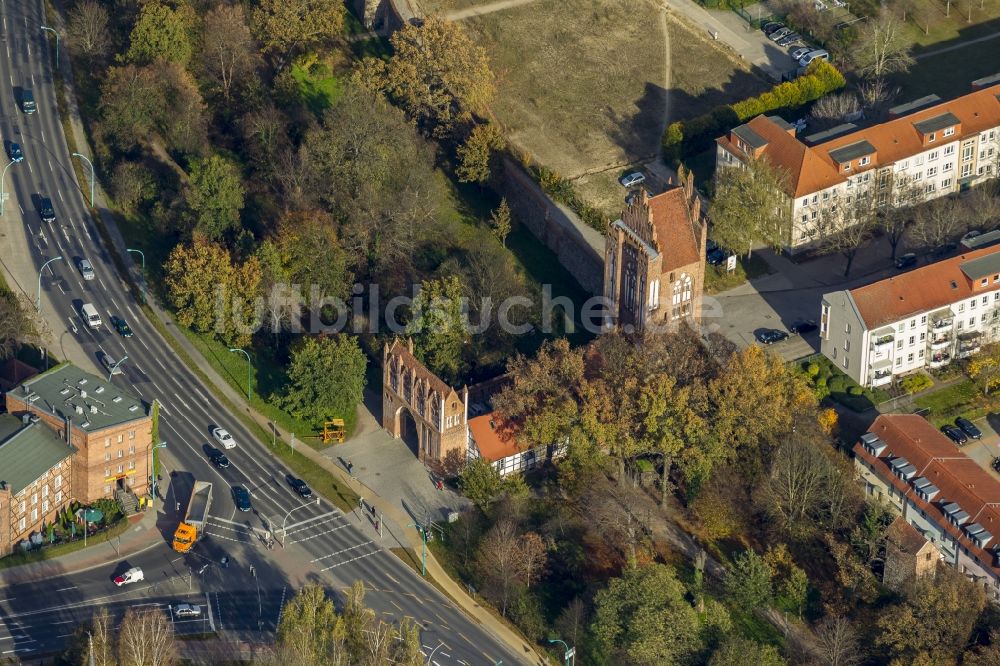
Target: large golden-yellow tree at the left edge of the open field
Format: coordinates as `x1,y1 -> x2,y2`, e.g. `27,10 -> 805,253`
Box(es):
356,16 -> 496,133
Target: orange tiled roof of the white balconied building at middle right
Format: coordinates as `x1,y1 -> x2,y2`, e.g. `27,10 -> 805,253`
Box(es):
851,246 -> 1000,329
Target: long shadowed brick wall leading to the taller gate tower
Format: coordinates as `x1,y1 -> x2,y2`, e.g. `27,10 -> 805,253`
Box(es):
498,159 -> 604,295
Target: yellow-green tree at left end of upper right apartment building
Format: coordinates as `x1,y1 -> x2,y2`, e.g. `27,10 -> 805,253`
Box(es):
710,158 -> 790,256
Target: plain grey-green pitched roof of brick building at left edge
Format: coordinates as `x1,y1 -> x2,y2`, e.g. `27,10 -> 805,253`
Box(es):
0,414 -> 76,495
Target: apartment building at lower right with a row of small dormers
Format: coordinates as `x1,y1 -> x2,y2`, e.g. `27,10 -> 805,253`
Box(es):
854,414 -> 1000,602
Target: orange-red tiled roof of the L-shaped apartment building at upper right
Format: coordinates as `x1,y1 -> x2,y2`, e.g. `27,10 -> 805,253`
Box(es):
717,84 -> 1000,197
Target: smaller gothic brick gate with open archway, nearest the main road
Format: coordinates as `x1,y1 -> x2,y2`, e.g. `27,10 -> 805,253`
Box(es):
382,339 -> 469,466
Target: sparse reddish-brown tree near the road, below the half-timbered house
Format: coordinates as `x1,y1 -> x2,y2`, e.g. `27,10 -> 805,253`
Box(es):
476,518 -> 546,617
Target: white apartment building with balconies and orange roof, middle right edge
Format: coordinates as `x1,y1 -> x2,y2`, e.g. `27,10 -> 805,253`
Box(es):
819,246 -> 1000,386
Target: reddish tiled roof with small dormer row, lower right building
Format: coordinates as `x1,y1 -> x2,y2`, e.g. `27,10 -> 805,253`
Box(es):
854,414 -> 1000,577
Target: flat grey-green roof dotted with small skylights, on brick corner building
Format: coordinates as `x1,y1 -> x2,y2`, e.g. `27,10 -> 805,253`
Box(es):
11,363 -> 151,432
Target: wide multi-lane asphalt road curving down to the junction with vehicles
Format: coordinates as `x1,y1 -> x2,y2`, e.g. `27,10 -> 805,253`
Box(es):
0,0 -> 523,666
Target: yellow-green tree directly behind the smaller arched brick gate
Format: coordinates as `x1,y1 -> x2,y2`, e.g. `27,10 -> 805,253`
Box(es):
406,275 -> 469,382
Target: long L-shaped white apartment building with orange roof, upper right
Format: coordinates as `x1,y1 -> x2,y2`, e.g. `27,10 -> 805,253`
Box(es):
716,74 -> 1000,252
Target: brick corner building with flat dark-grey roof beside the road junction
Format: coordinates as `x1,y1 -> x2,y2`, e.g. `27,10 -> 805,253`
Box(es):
6,363 -> 153,503
